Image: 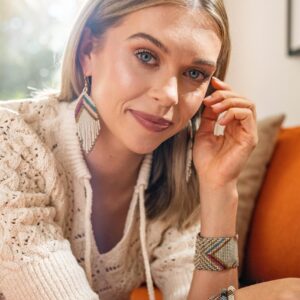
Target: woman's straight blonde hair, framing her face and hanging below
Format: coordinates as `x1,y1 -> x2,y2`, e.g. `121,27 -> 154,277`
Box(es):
58,0 -> 231,228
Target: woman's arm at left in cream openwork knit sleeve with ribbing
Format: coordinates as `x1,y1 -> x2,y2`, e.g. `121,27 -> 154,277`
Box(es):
0,109 -> 98,300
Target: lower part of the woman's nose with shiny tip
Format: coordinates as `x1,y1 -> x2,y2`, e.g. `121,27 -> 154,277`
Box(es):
151,76 -> 178,107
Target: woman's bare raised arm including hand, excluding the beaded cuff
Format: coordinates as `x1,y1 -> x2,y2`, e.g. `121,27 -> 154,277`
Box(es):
188,78 -> 258,300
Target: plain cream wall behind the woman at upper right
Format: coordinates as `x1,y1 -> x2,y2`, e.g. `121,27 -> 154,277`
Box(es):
224,0 -> 300,126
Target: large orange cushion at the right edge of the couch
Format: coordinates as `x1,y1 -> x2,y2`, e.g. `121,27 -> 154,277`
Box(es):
243,127 -> 300,282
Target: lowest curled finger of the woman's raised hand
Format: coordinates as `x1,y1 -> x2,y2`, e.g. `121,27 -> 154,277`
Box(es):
218,108 -> 256,133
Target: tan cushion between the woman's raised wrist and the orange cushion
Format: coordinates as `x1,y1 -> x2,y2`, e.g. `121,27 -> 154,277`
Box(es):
237,114 -> 284,274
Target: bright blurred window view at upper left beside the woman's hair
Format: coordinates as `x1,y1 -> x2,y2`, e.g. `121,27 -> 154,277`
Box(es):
0,0 -> 83,99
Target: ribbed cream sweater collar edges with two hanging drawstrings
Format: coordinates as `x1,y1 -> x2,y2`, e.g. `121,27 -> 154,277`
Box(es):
58,98 -> 155,300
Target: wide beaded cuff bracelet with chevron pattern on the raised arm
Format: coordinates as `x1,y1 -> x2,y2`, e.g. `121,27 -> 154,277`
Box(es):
194,233 -> 239,271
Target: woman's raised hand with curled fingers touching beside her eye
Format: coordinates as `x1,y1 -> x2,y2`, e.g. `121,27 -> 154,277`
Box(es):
193,77 -> 258,187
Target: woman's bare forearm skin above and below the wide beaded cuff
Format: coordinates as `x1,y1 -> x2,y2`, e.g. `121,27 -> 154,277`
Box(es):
188,184 -> 238,300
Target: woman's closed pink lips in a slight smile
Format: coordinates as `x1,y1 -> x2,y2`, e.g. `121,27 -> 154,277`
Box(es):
129,109 -> 173,132
